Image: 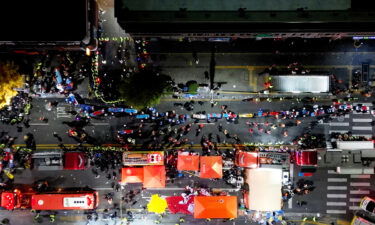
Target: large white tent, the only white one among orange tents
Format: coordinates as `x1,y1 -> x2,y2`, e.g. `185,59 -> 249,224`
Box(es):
245,168 -> 282,211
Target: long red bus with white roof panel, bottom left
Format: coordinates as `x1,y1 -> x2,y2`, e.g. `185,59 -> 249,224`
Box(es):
31,191 -> 99,210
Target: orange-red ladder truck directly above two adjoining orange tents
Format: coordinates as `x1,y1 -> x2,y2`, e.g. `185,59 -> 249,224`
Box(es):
122,151 -> 164,166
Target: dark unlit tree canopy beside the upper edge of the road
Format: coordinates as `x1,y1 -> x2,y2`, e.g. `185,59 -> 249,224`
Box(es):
119,70 -> 172,109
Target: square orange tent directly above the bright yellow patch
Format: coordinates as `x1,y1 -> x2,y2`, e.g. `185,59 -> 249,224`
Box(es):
143,166 -> 165,188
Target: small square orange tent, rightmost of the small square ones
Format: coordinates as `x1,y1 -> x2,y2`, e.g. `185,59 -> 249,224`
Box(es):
199,156 -> 223,178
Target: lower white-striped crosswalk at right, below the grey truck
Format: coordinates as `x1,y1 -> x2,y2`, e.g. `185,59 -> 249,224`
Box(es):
326,170 -> 371,214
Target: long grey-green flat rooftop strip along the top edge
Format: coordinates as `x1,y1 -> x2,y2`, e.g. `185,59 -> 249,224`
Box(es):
120,0 -> 351,11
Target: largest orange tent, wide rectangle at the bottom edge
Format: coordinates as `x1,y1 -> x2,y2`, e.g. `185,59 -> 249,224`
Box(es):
194,196 -> 237,219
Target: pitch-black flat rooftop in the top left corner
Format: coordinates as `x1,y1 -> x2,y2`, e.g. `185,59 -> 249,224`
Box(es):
0,0 -> 88,42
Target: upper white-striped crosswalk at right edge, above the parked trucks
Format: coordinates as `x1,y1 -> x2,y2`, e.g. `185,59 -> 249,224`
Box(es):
327,103 -> 374,137
